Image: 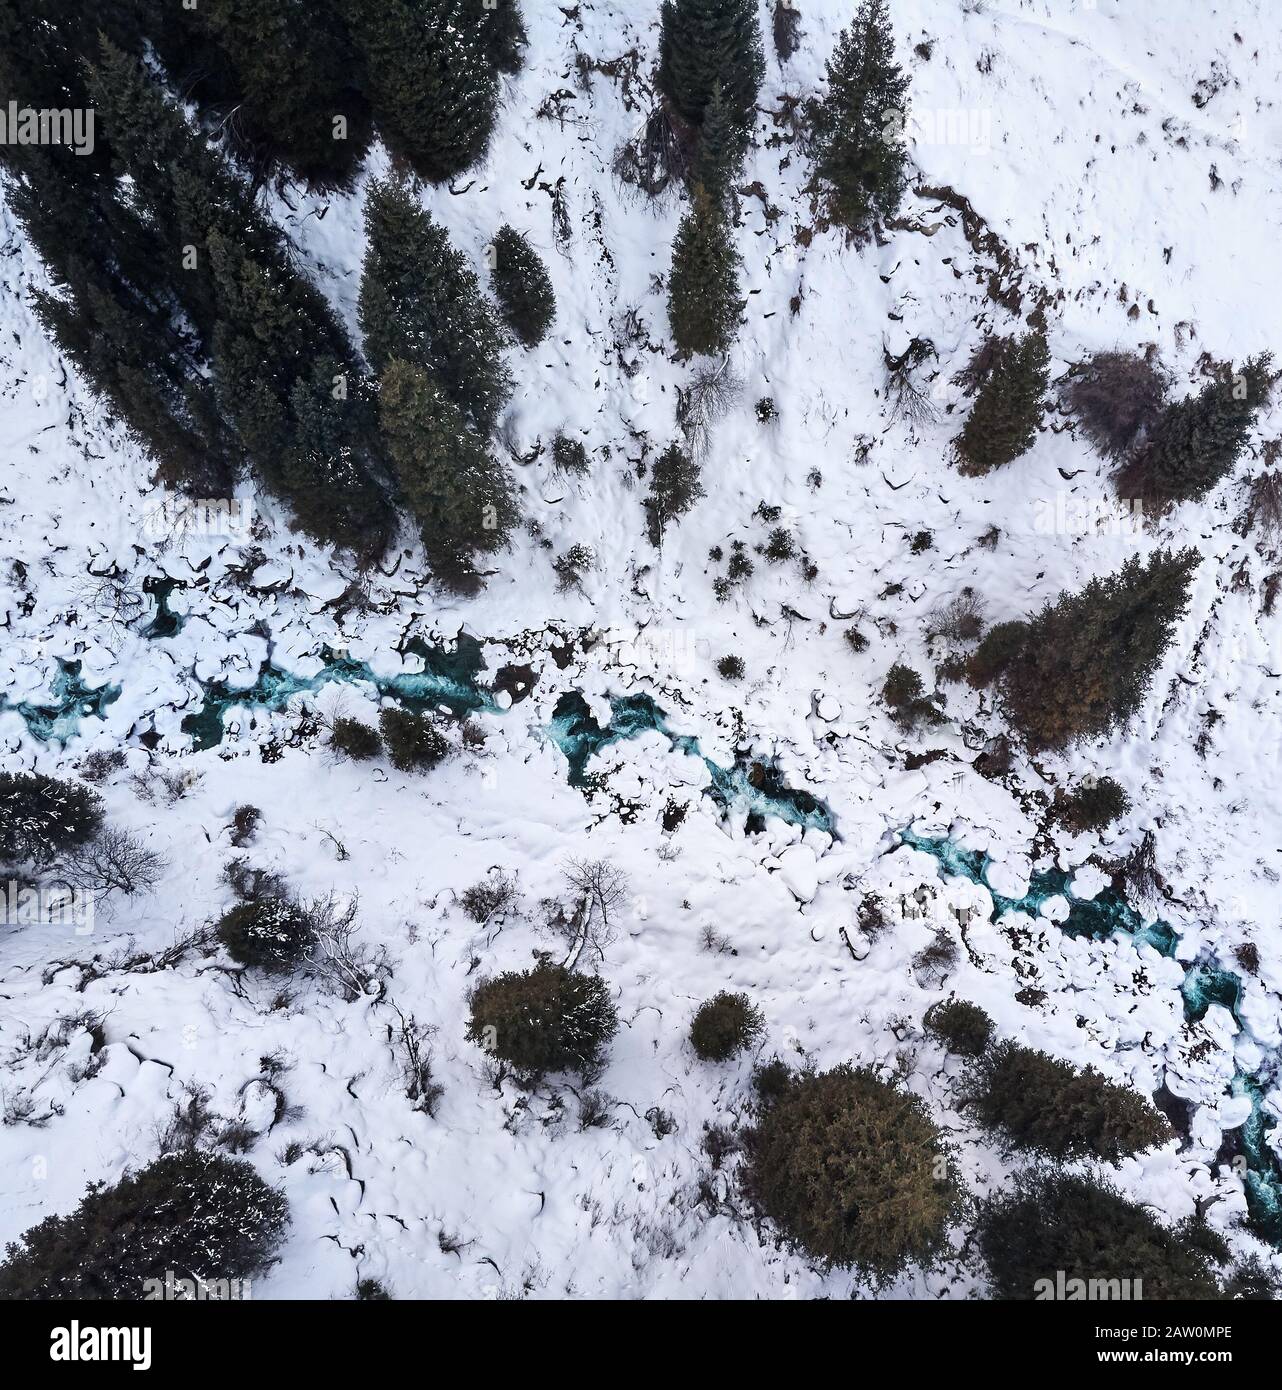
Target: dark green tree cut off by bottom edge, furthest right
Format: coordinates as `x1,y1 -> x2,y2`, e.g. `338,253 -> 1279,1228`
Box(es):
976,1170 -> 1219,1300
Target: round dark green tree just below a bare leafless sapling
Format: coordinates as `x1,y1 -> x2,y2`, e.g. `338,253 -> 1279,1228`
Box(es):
467,960 -> 619,1079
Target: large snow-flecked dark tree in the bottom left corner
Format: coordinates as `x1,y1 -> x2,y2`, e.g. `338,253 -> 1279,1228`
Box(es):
0,1150 -> 289,1300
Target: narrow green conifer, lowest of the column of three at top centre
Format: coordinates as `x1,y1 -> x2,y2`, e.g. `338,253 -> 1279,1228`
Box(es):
667,186 -> 743,354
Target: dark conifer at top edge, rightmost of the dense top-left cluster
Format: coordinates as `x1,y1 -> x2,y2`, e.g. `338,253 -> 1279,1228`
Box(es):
348,0 -> 498,183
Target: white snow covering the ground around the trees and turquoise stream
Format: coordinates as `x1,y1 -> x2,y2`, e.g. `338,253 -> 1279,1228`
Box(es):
0,0 -> 1282,1298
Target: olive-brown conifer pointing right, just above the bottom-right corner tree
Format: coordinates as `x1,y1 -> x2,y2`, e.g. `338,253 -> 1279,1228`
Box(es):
966,1043 -> 1171,1163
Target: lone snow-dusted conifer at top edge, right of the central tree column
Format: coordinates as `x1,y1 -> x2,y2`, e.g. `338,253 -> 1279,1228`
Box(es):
813,0 -> 908,232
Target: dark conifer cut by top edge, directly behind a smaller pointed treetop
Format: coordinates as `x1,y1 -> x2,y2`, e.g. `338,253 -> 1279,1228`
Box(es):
658,0 -> 766,142
